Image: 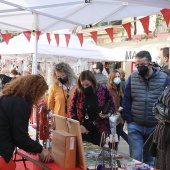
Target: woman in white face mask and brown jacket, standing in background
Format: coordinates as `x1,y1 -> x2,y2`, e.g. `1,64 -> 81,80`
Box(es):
108,70 -> 128,143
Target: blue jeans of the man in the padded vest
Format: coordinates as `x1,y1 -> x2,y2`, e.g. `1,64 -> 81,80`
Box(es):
127,122 -> 155,167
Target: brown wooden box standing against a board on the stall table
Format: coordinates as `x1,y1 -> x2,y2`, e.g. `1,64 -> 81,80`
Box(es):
52,130 -> 76,168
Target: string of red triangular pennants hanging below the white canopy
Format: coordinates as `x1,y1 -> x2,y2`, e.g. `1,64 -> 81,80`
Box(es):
1,9 -> 170,47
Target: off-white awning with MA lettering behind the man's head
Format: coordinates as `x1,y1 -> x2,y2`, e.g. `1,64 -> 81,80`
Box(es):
102,36 -> 170,61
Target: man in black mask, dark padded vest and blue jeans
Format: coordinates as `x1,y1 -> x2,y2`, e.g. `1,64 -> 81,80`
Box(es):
122,51 -> 170,166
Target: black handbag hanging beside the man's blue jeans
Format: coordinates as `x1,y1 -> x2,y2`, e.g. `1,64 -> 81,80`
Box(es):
143,131 -> 157,157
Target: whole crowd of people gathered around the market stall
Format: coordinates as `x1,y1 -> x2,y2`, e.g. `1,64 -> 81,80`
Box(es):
0,48 -> 170,170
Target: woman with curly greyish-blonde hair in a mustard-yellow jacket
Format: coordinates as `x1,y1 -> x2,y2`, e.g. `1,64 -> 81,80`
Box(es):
48,62 -> 76,117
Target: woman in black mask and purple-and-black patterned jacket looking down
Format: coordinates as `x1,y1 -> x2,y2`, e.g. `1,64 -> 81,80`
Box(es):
69,70 -> 115,145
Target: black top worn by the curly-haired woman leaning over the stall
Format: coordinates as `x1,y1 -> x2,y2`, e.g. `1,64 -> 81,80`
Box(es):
0,96 -> 43,162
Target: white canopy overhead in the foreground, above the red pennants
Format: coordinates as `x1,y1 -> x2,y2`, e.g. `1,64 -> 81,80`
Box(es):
0,0 -> 170,32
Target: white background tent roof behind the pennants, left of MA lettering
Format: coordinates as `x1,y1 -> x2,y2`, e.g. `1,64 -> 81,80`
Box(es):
0,30 -> 118,63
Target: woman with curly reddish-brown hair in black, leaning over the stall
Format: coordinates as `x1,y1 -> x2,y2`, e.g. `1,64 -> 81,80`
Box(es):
0,75 -> 51,170
